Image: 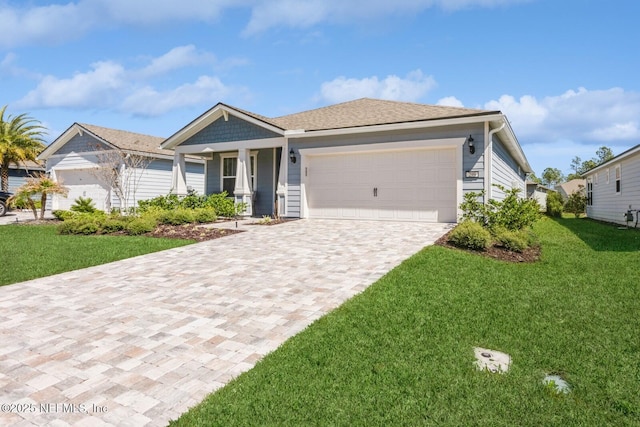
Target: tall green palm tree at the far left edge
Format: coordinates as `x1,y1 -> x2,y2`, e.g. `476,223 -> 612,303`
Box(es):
0,105 -> 45,191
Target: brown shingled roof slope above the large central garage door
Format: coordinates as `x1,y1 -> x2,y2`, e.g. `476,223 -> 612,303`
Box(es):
268,98 -> 499,131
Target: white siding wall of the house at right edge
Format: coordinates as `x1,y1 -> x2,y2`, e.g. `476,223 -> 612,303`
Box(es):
587,152 -> 640,224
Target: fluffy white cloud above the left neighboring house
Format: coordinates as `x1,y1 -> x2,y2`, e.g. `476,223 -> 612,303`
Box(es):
16,46 -> 246,116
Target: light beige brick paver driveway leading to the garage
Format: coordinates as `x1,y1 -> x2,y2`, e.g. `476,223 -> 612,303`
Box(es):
0,220 -> 449,426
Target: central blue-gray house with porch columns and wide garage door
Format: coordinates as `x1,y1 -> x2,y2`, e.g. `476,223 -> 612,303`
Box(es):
162,98 -> 532,222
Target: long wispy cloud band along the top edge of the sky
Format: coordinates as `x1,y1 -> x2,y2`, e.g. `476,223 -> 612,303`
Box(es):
0,0 -> 531,47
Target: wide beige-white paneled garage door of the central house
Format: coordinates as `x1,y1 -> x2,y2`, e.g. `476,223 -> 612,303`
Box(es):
304,149 -> 457,222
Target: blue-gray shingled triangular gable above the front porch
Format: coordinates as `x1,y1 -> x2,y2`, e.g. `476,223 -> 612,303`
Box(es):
180,115 -> 281,145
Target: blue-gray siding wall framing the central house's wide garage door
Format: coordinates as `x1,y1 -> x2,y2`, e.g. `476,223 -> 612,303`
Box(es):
287,123 -> 484,217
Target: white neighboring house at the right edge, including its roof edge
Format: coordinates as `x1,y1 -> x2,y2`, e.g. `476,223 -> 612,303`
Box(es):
582,145 -> 640,224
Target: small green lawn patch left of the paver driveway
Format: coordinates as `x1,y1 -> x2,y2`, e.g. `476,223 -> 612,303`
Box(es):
0,225 -> 193,286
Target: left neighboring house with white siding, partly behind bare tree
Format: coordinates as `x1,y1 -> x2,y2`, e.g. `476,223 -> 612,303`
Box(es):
38,123 -> 204,211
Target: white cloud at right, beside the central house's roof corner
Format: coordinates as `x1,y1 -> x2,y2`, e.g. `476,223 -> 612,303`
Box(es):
484,88 -> 640,143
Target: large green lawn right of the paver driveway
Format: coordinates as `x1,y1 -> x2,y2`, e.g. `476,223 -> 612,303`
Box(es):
172,219 -> 640,426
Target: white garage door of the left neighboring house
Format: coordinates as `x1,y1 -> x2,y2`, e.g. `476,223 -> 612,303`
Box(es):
54,169 -> 109,210
